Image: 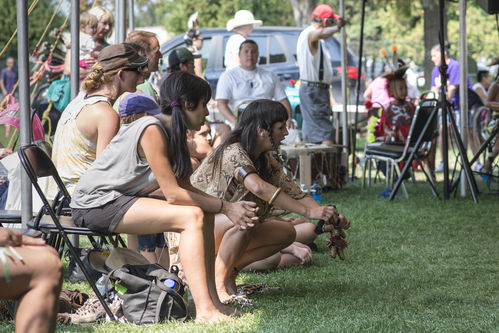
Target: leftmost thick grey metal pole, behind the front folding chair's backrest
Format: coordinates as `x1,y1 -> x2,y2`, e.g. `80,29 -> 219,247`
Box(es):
16,0 -> 33,228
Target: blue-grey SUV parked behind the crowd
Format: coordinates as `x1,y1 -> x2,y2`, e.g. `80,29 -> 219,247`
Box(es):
161,27 -> 365,118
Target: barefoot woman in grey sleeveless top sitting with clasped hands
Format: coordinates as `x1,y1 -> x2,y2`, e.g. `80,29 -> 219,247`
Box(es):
70,72 -> 258,322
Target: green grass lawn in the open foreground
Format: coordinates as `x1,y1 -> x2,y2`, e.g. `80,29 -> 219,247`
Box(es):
0,177 -> 499,332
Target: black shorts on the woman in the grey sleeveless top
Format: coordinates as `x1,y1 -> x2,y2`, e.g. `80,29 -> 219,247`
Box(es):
71,195 -> 139,234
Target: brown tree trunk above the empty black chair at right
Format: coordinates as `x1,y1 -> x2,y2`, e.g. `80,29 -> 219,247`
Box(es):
423,0 -> 447,90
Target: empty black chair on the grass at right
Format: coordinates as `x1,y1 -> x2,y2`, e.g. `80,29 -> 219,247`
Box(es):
362,99 -> 438,198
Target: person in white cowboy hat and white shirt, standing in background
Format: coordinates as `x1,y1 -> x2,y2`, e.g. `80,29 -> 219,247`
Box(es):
224,10 -> 262,70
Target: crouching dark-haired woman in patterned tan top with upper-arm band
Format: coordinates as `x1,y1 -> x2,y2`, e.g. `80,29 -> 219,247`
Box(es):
191,100 -> 349,301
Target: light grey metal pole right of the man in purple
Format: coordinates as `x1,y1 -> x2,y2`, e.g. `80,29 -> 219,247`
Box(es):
459,0 -> 469,197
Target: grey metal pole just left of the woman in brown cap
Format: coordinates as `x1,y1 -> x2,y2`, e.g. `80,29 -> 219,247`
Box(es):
71,0 -> 80,99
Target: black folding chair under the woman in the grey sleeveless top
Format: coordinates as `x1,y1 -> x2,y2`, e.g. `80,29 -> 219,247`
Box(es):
18,144 -> 125,320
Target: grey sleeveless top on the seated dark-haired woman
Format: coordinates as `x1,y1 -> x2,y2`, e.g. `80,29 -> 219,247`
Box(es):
70,116 -> 168,209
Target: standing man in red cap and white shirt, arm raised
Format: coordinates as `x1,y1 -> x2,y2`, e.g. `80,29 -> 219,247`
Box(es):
296,4 -> 346,145
